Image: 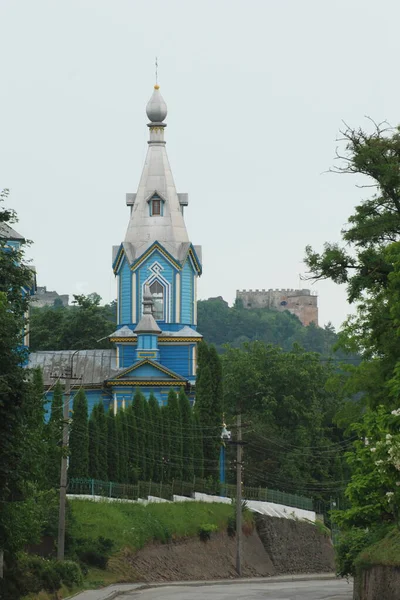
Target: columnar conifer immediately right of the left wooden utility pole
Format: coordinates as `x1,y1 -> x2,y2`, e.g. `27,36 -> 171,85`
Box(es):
68,388 -> 89,478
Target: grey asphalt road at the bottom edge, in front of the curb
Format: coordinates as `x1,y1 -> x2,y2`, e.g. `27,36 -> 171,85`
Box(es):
124,580 -> 353,600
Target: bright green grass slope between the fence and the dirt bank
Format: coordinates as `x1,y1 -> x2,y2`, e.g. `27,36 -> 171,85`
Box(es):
70,500 -> 244,550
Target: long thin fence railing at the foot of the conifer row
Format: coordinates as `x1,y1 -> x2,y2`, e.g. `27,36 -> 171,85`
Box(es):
68,477 -> 313,510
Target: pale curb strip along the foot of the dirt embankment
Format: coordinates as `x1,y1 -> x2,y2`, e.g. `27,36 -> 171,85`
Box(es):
65,573 -> 338,600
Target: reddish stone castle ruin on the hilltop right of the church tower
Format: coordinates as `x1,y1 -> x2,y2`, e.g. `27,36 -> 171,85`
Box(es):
236,289 -> 318,326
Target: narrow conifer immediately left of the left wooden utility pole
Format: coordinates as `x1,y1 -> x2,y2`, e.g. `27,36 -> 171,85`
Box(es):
46,381 -> 63,488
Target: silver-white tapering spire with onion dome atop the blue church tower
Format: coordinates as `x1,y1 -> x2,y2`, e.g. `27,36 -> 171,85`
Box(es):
125,85 -> 189,259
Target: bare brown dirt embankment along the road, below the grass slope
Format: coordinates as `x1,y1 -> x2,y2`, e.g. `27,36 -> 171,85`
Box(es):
109,516 -> 334,582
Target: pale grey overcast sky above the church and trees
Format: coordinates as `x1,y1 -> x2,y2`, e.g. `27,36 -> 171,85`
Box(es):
0,0 -> 400,327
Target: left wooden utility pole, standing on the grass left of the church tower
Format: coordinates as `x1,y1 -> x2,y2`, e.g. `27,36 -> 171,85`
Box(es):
57,367 -> 72,560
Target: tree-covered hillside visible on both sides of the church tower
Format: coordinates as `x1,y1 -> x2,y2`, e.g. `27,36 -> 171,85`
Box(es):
30,294 -> 349,359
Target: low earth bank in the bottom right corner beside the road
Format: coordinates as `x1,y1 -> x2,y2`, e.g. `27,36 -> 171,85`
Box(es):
354,565 -> 400,600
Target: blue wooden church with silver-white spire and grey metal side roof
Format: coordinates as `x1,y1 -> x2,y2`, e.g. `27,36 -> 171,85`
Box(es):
29,85 -> 202,410
